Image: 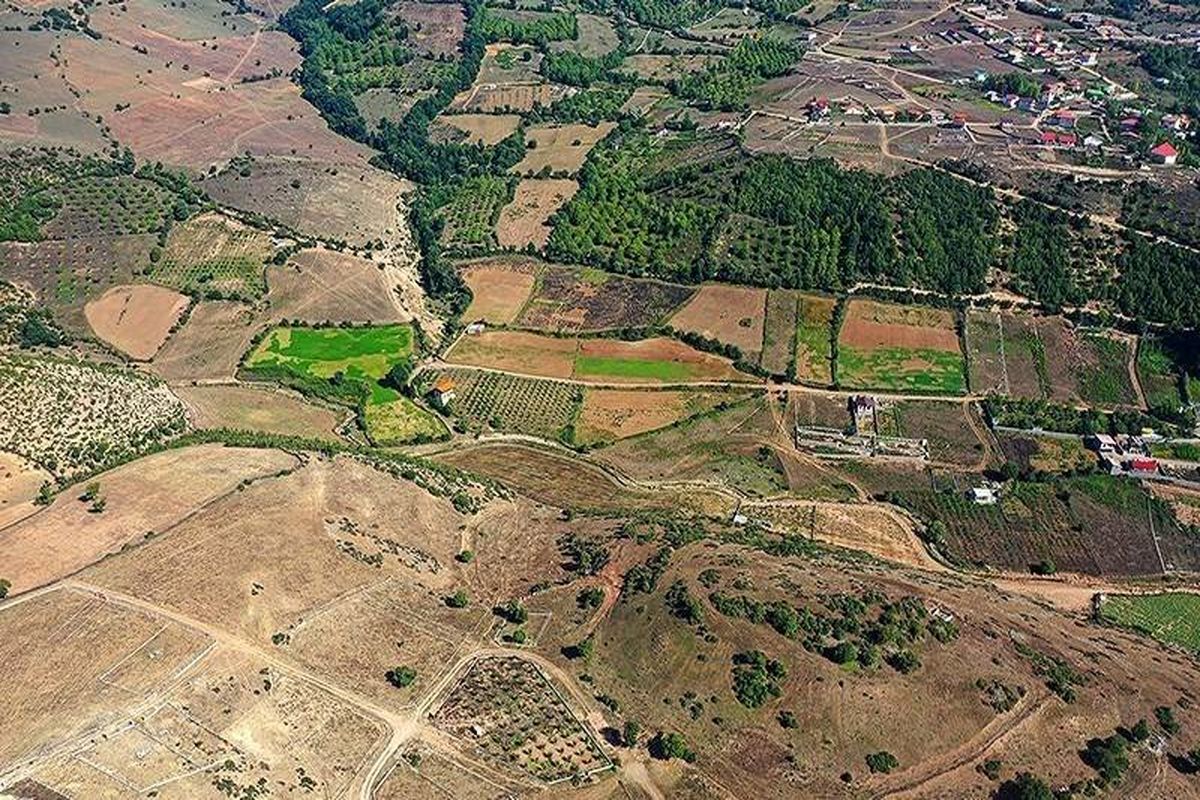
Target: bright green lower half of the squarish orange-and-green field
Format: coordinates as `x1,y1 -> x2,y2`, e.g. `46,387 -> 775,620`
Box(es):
838,344 -> 966,395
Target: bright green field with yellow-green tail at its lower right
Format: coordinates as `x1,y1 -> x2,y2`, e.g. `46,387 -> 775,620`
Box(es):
246,325 -> 444,445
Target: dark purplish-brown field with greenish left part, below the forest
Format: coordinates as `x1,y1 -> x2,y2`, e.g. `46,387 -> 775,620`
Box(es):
520,266 -> 694,331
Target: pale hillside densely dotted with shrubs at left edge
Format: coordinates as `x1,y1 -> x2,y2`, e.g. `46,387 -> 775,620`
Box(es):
0,353 -> 186,476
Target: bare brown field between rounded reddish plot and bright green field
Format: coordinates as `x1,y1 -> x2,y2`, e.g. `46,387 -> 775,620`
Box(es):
150,300 -> 258,381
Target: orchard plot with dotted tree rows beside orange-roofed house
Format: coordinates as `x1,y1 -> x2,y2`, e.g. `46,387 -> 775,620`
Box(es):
422,369 -> 580,439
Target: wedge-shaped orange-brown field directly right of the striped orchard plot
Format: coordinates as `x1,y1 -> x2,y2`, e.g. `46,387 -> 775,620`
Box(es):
575,389 -> 748,445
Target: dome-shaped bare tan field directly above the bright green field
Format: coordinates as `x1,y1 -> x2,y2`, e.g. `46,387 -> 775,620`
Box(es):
266,249 -> 409,324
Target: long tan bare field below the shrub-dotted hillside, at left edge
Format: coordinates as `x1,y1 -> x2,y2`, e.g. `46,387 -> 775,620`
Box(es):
0,445 -> 298,591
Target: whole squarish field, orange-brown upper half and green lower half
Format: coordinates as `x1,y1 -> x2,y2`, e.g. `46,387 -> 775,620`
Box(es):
838,300 -> 966,395
